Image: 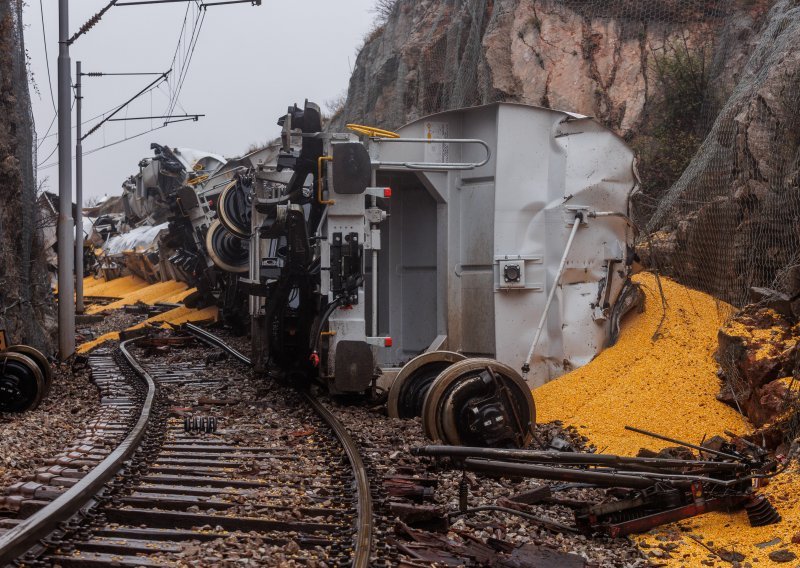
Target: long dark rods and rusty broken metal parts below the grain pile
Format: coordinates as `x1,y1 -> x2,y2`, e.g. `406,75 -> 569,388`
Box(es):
414,432 -> 780,537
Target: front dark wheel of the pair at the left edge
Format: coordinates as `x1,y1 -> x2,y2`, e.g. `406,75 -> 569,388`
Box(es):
0,351 -> 45,412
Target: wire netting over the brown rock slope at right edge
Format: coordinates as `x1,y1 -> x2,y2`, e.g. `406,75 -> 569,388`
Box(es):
645,2 -> 800,306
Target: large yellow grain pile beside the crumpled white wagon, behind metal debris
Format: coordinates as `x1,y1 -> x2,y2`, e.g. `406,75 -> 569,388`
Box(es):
534,273 -> 749,455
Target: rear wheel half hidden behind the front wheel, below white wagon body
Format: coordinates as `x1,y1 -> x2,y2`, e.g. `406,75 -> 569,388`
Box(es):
387,351 -> 466,418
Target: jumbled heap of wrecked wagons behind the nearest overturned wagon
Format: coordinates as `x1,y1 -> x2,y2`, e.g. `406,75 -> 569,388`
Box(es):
95,144 -> 269,330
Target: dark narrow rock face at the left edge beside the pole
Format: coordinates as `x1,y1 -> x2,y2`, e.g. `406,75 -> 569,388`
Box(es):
0,0 -> 55,353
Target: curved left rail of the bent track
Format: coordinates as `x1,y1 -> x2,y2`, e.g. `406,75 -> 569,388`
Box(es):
0,339 -> 156,566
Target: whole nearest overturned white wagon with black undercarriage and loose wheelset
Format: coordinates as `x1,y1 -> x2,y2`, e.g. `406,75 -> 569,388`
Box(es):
247,103 -> 637,445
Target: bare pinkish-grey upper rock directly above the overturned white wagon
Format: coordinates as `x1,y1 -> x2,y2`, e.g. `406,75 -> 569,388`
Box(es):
334,0 -> 763,137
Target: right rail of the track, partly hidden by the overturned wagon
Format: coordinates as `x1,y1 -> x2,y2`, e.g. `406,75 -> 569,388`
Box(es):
183,323 -> 374,568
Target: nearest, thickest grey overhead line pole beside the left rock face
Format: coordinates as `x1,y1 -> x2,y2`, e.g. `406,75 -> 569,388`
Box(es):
58,0 -> 75,361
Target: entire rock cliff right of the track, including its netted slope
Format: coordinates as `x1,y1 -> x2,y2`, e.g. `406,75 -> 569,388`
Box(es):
332,0 -> 800,305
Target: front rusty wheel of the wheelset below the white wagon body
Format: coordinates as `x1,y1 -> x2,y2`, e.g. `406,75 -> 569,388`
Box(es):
422,358 -> 536,448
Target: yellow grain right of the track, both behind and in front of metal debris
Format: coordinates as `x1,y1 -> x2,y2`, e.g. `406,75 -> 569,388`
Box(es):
534,273 -> 800,568
